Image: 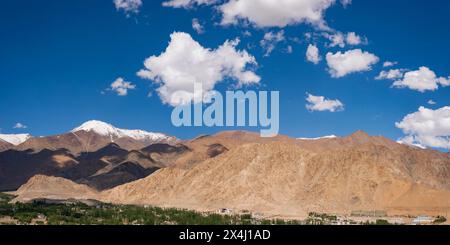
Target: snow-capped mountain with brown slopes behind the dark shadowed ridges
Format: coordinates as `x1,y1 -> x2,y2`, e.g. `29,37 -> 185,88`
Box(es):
15,121 -> 178,154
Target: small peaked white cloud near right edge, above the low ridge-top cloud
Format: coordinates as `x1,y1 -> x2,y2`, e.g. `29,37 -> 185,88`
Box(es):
392,66 -> 450,93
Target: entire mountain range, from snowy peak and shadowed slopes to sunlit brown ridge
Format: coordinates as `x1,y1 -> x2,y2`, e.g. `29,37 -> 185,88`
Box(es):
0,121 -> 450,217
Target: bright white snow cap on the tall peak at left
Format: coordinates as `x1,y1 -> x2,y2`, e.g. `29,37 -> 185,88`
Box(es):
71,120 -> 171,141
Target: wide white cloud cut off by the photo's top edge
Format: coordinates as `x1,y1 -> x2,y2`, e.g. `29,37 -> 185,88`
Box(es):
219,0 -> 335,29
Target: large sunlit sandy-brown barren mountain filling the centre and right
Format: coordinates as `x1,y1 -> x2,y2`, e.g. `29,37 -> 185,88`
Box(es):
12,131 -> 450,217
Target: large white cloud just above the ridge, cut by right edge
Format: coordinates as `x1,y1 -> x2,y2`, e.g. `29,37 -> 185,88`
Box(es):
395,106 -> 450,149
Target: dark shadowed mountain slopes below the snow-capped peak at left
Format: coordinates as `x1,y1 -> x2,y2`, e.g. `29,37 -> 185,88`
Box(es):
0,143 -> 165,191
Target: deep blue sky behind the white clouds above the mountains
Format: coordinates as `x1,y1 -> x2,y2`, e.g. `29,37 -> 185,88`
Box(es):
0,0 -> 450,147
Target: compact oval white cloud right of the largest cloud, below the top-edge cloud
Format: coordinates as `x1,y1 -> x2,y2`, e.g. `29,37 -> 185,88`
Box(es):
326,49 -> 379,78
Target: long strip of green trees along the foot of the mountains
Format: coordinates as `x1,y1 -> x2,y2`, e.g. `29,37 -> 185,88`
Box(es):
0,194 -> 299,225
